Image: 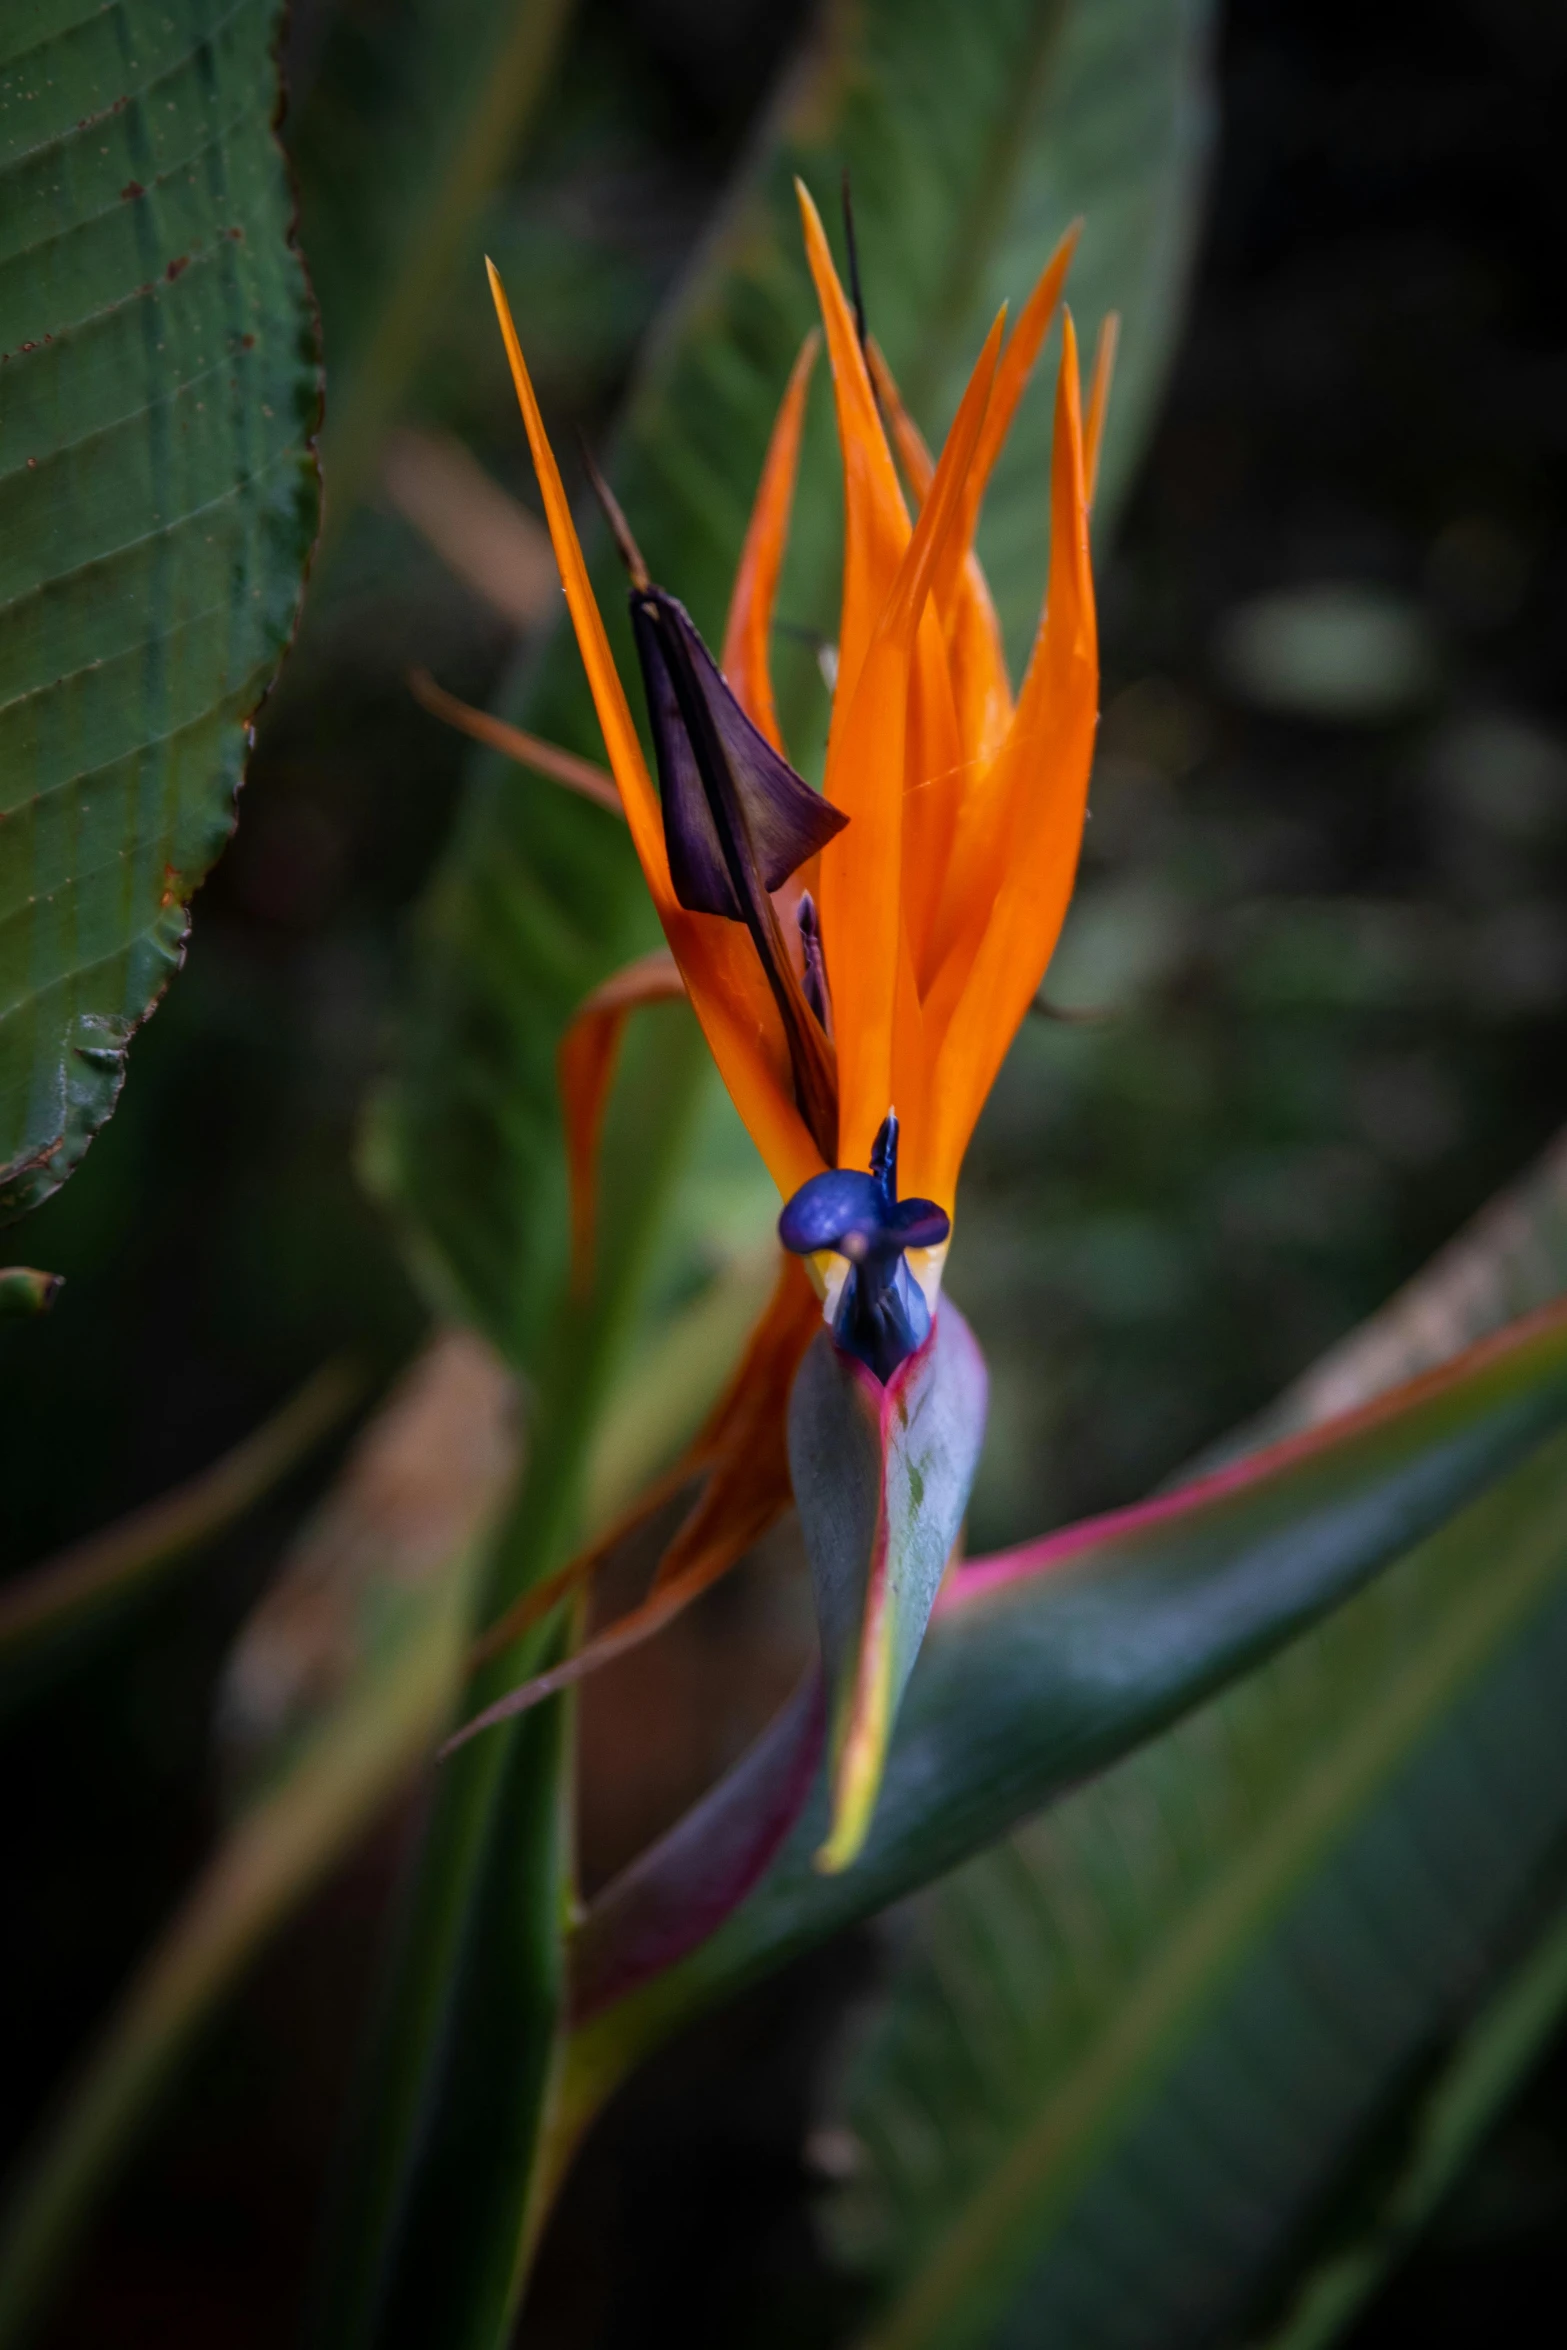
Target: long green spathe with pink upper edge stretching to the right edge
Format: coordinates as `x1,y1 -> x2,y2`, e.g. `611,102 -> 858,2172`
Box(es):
557,1304 -> 1567,2150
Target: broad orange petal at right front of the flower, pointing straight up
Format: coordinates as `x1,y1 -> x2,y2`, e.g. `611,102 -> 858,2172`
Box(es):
904,313 -> 1099,1199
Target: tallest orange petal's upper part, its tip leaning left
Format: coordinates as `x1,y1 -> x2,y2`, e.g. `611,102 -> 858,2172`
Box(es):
794,181 -> 909,726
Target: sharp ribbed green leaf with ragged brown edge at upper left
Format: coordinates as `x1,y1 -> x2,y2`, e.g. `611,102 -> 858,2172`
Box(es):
0,0 -> 320,1215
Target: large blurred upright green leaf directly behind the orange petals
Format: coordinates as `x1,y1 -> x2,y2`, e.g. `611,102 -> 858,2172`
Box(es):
374,0 -> 1208,1363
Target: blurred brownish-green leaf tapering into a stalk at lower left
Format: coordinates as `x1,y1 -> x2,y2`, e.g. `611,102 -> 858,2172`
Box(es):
0,1332 -> 517,2345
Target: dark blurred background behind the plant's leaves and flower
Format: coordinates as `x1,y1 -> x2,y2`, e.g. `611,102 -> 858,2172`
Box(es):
0,0 -> 1567,2350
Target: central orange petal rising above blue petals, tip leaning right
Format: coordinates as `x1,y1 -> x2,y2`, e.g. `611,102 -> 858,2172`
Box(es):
822,317 -> 1003,1166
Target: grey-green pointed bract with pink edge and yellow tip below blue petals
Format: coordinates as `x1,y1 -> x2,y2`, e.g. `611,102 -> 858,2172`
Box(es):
789,1300 -> 989,1871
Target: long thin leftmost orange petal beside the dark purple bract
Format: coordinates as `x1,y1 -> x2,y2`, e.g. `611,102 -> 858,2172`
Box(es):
486,261 -> 822,1199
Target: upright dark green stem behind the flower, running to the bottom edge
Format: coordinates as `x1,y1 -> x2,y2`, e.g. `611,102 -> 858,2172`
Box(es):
315,1006 -> 712,2350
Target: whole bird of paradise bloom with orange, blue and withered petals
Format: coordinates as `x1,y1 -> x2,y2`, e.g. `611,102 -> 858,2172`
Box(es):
441,186 -> 1114,1868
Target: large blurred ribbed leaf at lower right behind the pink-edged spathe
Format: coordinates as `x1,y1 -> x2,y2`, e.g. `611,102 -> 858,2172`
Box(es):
836,1128 -> 1567,2350
